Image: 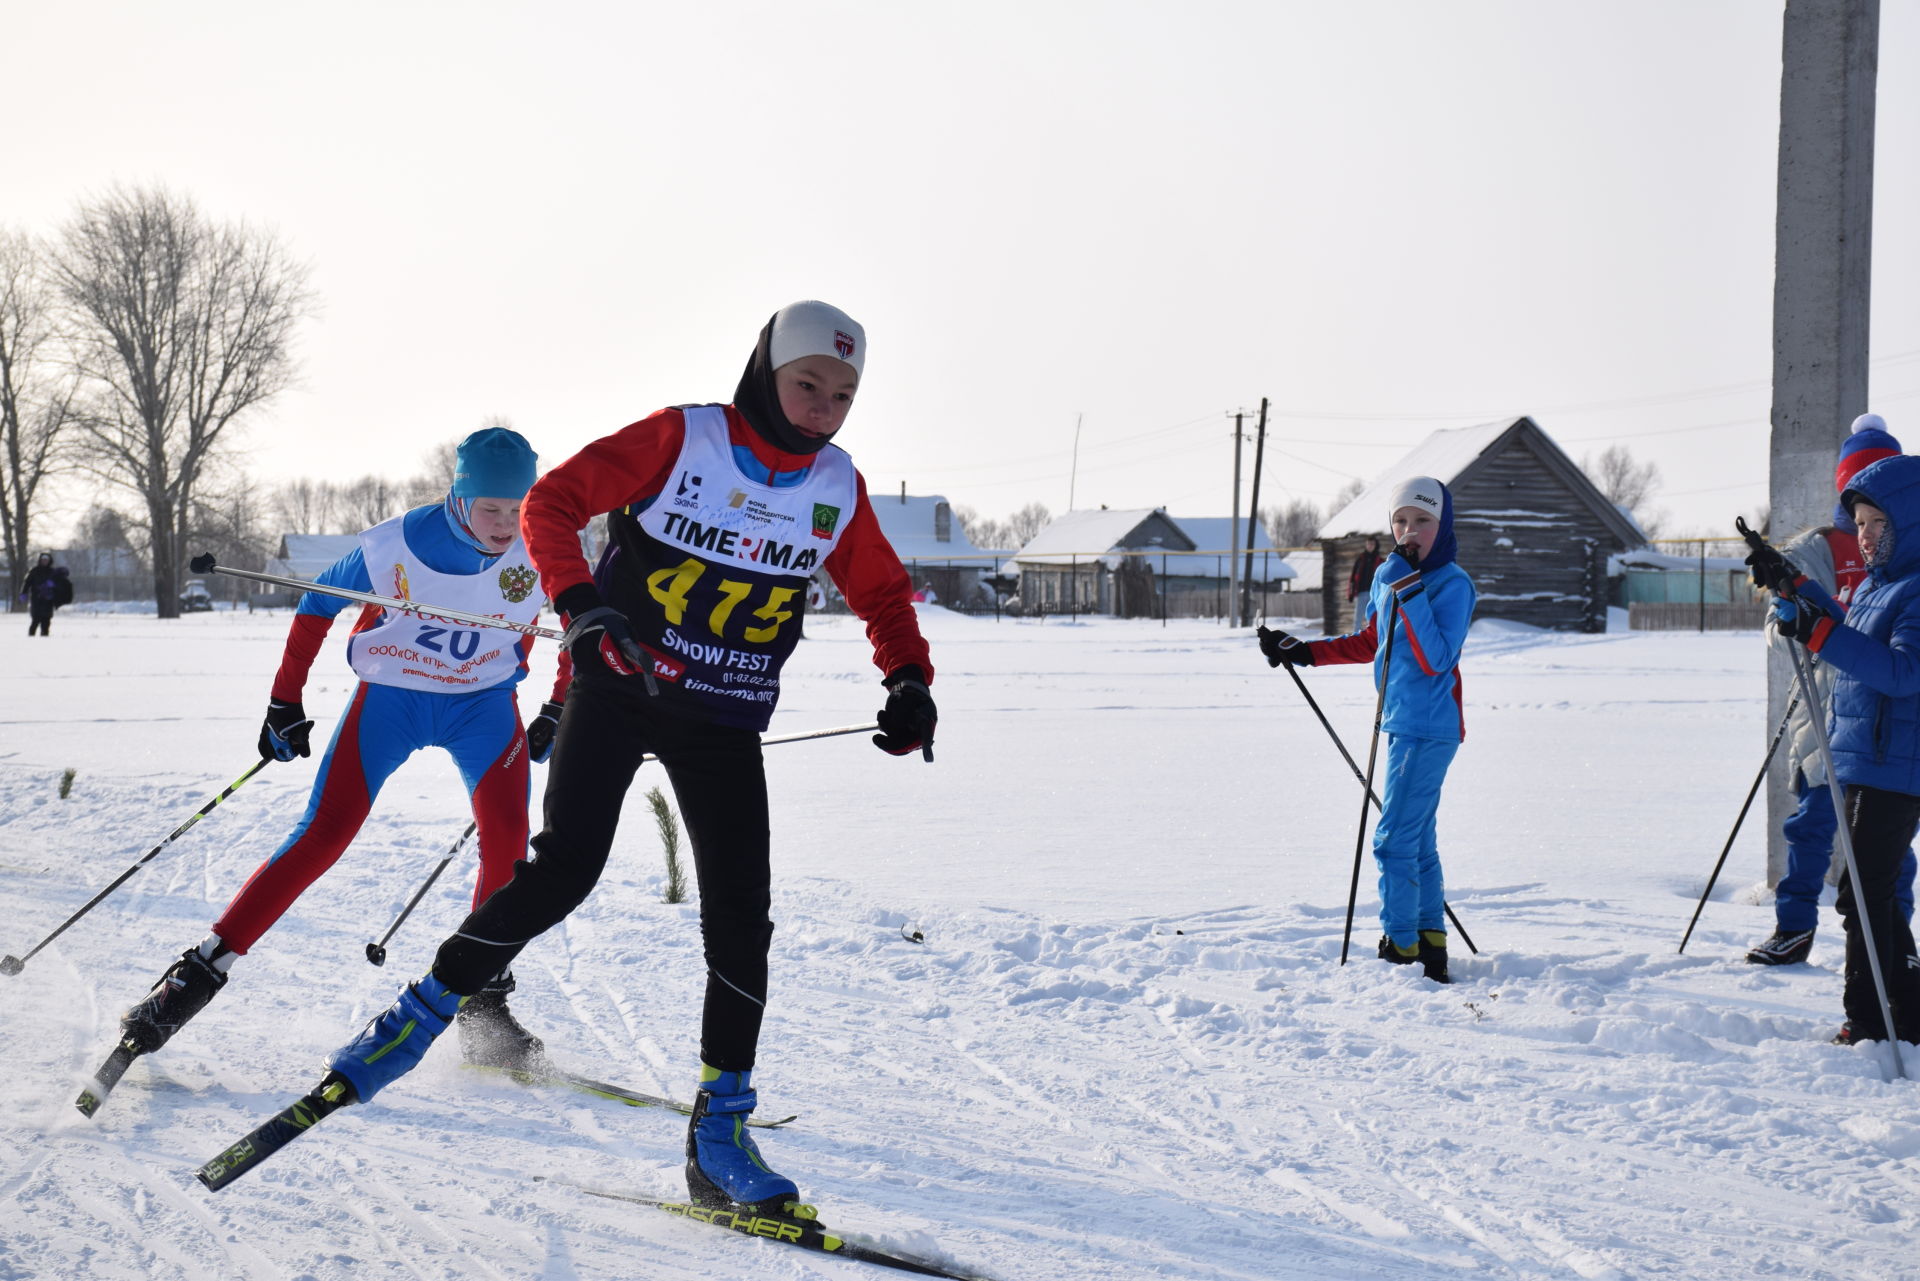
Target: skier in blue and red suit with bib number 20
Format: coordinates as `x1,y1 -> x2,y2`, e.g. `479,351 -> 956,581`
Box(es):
98,428 -> 568,1110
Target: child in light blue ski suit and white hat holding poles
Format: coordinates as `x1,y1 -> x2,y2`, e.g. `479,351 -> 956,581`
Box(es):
1260,476 -> 1475,983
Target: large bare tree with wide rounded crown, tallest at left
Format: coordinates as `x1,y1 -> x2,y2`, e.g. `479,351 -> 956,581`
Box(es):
54,186 -> 313,618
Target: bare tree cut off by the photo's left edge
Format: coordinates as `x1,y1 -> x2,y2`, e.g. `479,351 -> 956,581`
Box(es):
0,230 -> 73,609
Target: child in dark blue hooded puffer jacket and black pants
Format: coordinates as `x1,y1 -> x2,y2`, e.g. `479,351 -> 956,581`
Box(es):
1768,457 -> 1920,1045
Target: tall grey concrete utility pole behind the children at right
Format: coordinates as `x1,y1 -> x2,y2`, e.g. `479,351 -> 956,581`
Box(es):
1766,0 -> 1880,883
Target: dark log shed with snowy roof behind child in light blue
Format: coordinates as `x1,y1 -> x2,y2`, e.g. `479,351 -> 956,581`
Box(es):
1319,417 -> 1645,636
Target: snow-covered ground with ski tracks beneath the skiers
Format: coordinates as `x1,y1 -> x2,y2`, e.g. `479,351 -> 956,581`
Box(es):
0,609 -> 1920,1281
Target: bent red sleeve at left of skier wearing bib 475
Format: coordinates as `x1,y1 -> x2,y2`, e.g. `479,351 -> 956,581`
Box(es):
520,409 -> 687,599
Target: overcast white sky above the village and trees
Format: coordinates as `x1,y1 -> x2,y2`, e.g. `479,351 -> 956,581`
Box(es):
15,0 -> 1920,532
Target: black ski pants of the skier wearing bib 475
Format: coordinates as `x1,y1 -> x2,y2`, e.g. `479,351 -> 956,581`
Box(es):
434,672 -> 774,1072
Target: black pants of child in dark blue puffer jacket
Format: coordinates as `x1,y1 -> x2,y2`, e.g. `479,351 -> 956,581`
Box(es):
1836,786 -> 1920,1041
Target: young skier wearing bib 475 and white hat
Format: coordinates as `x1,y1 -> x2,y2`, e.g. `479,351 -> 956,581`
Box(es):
330,302 -> 935,1216
